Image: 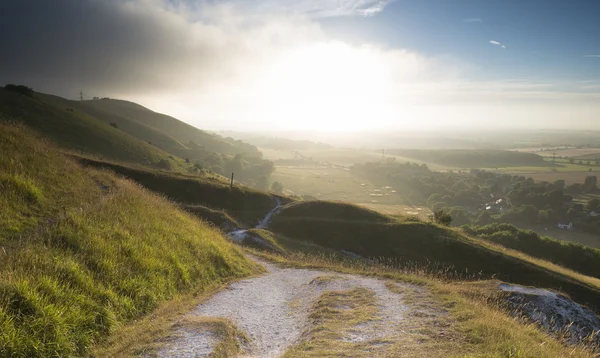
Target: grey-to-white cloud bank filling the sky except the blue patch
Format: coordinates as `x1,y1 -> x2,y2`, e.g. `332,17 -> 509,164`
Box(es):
0,0 -> 600,130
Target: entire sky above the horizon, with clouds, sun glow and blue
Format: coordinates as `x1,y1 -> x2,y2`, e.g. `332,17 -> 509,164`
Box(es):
0,0 -> 600,132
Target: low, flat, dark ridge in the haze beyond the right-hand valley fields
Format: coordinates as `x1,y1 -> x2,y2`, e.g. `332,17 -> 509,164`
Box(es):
387,149 -> 548,168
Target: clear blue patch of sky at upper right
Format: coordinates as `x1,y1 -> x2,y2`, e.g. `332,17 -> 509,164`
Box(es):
319,0 -> 600,81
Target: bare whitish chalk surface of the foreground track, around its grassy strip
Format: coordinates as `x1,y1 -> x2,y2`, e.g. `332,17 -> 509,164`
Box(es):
158,258 -> 410,358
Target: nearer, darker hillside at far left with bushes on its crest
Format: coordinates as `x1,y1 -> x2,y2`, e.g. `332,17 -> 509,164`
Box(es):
0,88 -> 182,168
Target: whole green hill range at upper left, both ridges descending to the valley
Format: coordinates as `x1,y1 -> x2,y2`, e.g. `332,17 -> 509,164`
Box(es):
0,86 -> 274,183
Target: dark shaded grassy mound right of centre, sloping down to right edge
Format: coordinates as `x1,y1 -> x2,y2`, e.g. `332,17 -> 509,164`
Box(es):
269,202 -> 600,311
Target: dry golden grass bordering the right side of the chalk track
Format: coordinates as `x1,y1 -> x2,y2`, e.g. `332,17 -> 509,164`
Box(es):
248,250 -> 594,358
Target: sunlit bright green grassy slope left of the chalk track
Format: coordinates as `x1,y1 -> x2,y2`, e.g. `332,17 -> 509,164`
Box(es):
0,124 -> 254,357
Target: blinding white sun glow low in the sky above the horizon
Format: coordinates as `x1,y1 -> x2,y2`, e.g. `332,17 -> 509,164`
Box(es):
257,42 -> 392,131
